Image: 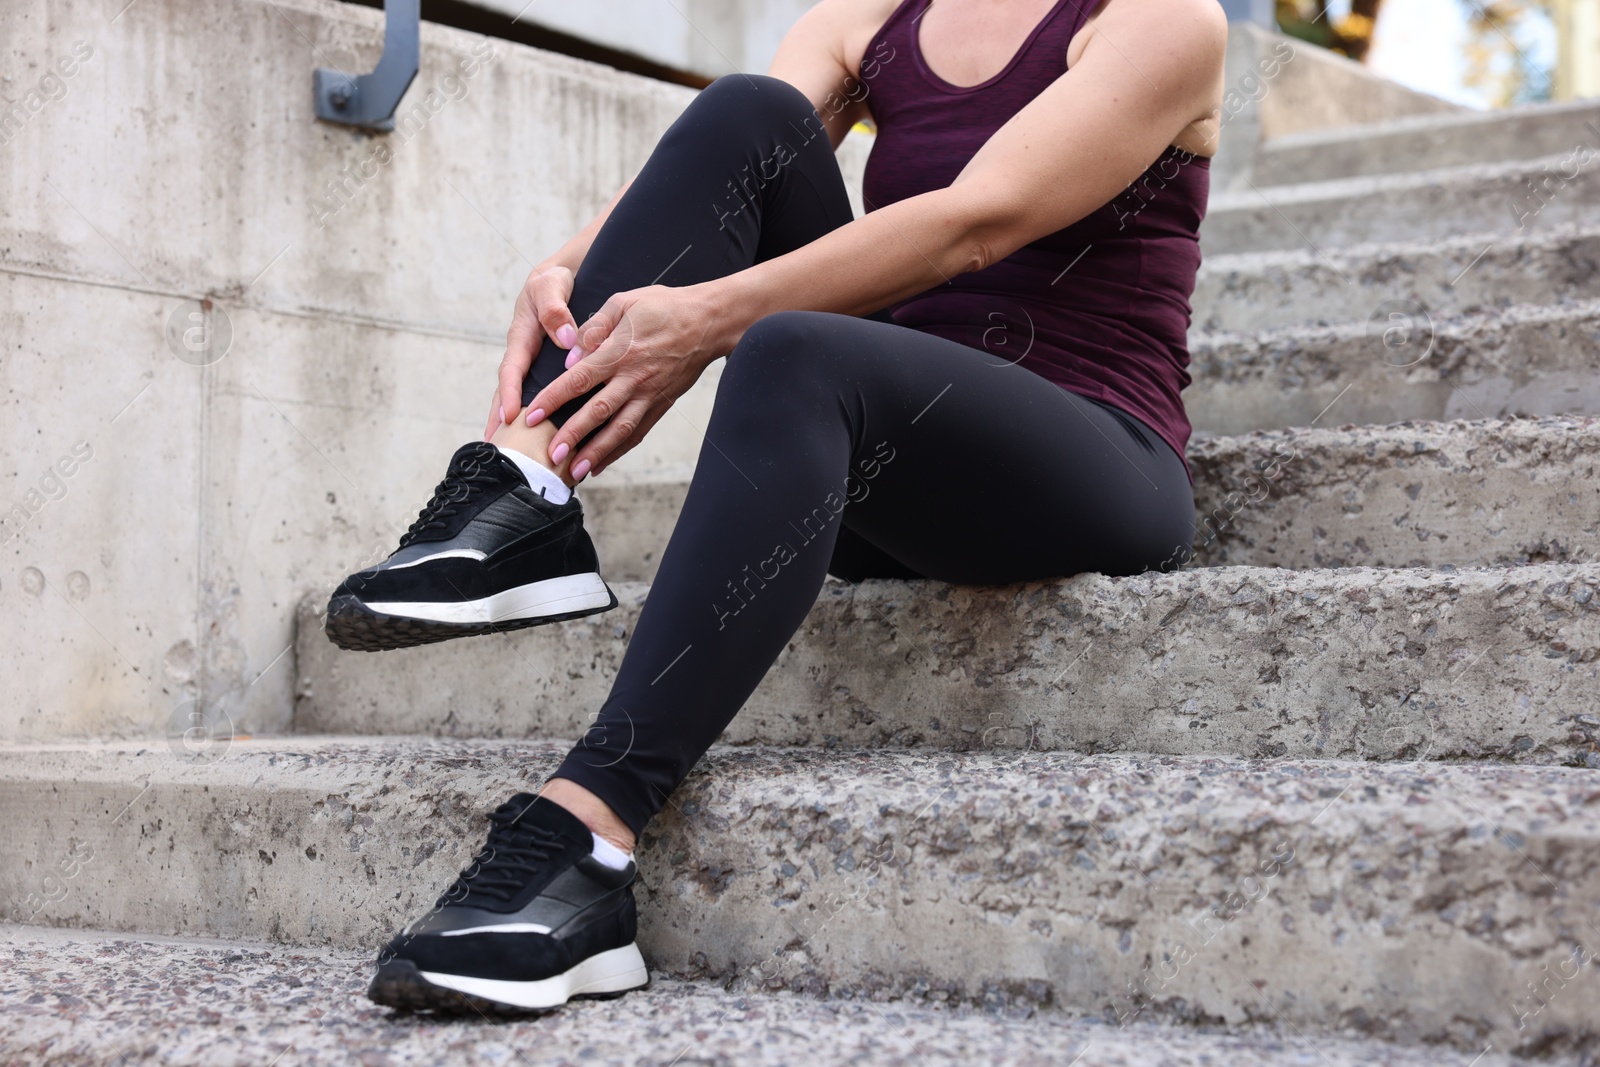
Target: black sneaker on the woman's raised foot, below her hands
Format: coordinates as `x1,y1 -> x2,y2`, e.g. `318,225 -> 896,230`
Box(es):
328,442 -> 616,653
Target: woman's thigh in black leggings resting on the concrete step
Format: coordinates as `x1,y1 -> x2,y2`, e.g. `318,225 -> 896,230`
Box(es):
787,315 -> 1195,584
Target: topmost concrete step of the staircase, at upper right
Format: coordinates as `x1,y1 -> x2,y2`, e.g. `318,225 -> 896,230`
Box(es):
1251,101 -> 1600,186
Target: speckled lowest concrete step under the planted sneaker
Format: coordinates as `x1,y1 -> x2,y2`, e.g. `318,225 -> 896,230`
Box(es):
0,926 -> 1536,1067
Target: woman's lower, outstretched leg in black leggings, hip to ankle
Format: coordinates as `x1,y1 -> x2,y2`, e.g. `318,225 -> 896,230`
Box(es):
557,312 -> 1194,833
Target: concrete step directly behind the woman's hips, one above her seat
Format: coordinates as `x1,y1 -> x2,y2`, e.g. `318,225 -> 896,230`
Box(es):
582,418 -> 1600,581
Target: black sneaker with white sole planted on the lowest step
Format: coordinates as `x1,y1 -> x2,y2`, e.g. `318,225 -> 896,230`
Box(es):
366,793 -> 650,1014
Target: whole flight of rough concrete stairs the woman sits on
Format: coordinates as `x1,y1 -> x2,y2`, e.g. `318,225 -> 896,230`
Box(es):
0,5 -> 1600,1065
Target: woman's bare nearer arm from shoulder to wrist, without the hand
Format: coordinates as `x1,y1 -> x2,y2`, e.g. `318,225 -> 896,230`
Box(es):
707,0 -> 1227,350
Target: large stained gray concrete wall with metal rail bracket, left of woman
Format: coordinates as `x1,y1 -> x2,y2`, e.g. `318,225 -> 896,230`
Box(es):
0,0 -> 704,739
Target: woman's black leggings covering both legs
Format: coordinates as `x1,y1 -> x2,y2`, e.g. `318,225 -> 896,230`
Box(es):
523,75 -> 1195,832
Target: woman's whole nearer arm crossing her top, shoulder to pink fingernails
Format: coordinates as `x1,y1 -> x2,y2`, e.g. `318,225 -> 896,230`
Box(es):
530,0 -> 1227,470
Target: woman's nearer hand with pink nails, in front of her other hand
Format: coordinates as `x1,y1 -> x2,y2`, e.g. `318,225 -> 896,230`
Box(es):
526,285 -> 733,478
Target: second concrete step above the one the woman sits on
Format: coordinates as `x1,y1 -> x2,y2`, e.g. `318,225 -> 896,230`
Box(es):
1184,299 -> 1600,434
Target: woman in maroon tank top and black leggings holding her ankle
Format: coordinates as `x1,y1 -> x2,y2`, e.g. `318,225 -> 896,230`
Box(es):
328,0 -> 1227,1011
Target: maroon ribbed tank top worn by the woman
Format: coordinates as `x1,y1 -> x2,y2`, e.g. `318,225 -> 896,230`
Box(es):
861,0 -> 1211,462
